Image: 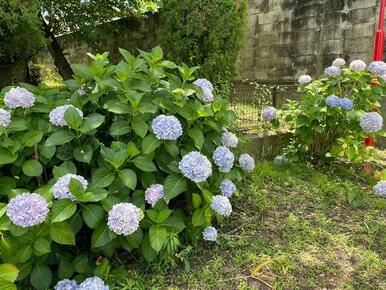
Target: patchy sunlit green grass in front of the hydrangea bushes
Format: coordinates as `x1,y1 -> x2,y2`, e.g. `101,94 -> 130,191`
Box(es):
109,162 -> 386,289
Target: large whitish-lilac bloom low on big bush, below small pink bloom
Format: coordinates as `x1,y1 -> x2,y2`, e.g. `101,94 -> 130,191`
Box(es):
107,202 -> 143,236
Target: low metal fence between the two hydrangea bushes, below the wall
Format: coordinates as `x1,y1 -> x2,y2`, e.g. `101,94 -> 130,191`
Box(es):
230,82 -> 299,132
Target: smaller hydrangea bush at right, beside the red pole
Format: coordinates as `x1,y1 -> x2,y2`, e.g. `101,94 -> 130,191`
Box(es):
263,59 -> 386,164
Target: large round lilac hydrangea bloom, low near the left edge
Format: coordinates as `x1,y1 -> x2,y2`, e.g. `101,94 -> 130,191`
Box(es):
7,192 -> 49,228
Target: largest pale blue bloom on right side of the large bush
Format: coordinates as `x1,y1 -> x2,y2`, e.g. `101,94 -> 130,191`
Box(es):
178,151 -> 212,182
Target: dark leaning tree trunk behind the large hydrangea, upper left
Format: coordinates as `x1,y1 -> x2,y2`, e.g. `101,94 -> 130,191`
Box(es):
42,17 -> 74,80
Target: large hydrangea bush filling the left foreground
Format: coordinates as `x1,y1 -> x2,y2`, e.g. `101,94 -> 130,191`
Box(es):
0,47 -> 254,289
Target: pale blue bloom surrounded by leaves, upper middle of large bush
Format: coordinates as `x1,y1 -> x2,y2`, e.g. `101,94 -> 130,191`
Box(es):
151,115 -> 182,140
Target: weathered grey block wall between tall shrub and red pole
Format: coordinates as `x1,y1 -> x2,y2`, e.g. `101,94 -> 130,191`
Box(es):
239,0 -> 379,82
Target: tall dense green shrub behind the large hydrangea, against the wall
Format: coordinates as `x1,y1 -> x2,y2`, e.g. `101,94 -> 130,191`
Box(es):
160,0 -> 247,96
